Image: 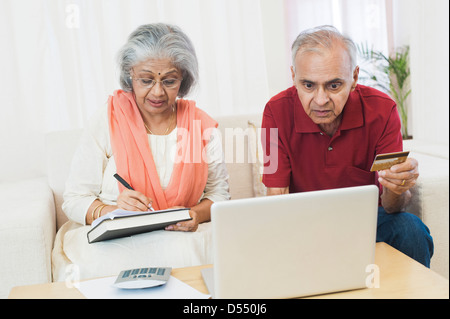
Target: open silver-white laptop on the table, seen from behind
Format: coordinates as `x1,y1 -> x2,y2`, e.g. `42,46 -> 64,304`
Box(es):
202,185 -> 378,299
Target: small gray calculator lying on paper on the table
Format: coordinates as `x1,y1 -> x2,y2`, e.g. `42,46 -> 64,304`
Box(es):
113,267 -> 172,289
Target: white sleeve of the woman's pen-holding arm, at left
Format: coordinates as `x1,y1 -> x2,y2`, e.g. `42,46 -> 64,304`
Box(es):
62,108 -> 112,225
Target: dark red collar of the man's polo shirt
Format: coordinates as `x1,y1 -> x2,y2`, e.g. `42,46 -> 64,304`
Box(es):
294,86 -> 364,133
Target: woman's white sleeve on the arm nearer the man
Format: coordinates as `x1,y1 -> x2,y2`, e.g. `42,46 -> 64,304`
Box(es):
203,128 -> 230,202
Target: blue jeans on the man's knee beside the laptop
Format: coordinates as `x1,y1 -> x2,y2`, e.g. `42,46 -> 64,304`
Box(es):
377,207 -> 434,268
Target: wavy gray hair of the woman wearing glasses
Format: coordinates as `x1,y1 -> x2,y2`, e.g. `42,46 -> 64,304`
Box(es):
118,23 -> 198,97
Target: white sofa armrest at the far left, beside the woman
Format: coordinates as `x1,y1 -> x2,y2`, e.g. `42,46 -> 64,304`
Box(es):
0,178 -> 56,298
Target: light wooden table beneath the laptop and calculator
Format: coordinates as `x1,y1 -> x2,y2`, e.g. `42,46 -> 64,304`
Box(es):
9,243 -> 449,299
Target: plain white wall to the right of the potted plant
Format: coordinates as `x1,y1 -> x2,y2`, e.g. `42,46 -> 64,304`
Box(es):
394,0 -> 449,148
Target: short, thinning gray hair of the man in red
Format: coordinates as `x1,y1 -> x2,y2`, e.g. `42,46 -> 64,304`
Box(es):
292,25 -> 357,70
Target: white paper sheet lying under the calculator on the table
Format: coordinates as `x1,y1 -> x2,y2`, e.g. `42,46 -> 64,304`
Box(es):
78,276 -> 211,299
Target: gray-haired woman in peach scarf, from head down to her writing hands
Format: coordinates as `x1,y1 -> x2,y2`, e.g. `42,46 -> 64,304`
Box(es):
63,24 -> 229,231
